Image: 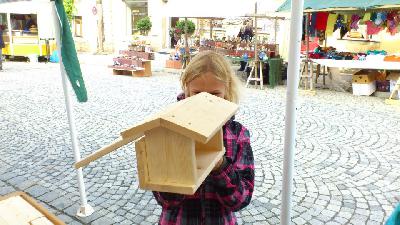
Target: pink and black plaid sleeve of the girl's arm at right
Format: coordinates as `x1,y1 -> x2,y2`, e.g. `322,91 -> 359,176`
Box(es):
210,127 -> 254,211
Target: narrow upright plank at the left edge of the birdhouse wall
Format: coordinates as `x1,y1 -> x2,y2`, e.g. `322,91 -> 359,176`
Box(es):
135,137 -> 149,188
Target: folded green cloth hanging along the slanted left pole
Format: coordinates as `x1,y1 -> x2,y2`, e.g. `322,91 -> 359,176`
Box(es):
55,0 -> 87,102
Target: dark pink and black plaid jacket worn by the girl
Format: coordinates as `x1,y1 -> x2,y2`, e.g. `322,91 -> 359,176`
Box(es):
153,95 -> 254,225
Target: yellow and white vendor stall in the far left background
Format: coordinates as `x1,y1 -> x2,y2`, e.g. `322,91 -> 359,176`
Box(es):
0,0 -> 56,59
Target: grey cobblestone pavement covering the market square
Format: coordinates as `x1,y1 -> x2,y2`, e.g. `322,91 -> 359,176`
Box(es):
0,56 -> 400,225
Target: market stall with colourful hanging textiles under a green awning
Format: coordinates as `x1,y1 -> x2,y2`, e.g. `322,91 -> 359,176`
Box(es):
278,0 -> 400,98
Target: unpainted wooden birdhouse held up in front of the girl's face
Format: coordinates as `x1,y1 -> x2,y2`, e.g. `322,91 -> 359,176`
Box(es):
75,92 -> 238,195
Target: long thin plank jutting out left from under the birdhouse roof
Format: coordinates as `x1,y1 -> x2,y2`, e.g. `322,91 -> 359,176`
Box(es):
74,133 -> 143,169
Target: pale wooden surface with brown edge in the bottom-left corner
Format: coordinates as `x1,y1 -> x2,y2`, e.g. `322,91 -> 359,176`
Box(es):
0,192 -> 65,225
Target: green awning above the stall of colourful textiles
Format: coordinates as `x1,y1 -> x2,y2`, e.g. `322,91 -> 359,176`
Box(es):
277,0 -> 400,12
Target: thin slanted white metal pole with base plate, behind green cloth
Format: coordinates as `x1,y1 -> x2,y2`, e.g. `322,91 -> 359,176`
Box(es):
52,2 -> 94,217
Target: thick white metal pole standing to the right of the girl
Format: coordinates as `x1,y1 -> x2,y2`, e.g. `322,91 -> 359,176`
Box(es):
281,0 -> 304,225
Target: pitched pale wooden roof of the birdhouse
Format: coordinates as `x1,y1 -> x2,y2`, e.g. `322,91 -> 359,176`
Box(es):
121,92 -> 239,143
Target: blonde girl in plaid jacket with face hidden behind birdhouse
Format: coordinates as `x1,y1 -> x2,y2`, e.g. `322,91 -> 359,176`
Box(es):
153,51 -> 254,225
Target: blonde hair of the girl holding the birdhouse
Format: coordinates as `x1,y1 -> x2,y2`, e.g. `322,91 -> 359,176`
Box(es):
181,51 -> 240,103
